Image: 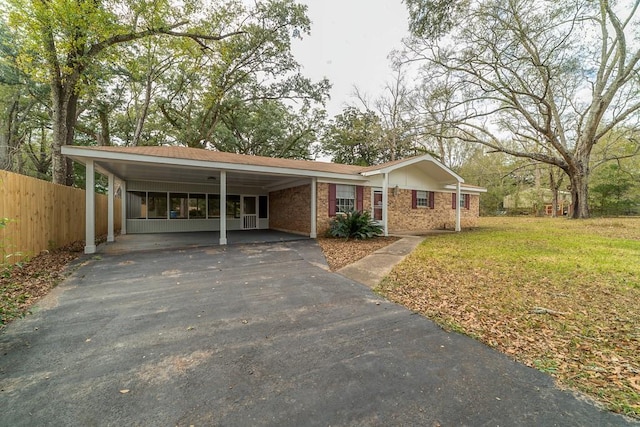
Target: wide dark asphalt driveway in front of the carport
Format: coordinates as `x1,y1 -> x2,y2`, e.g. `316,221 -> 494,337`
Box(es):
0,240 -> 631,426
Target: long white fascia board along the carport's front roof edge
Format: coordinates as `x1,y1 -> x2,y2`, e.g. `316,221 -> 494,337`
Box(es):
62,146 -> 362,181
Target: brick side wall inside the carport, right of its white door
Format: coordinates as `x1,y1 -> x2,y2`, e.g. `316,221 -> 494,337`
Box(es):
269,184 -> 311,235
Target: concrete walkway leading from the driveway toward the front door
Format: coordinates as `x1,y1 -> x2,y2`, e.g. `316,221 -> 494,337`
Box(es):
337,236 -> 425,289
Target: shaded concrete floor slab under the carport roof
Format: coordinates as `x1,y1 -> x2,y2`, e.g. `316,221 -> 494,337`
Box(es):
96,230 -> 309,254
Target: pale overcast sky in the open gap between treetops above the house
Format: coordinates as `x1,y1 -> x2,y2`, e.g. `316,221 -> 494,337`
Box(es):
293,0 -> 408,117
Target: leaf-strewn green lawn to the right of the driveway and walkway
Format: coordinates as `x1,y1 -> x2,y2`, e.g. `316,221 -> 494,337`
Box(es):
378,218 -> 640,418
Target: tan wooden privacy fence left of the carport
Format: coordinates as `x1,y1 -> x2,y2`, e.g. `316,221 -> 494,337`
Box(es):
0,170 -> 121,264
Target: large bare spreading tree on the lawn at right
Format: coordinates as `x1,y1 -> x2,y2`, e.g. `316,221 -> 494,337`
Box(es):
407,0 -> 640,218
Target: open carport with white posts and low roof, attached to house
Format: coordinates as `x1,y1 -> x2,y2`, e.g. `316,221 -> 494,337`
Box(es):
62,146 -> 366,254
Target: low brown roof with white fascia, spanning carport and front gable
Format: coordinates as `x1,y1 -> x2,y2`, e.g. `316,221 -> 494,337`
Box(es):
62,146 -> 480,190
